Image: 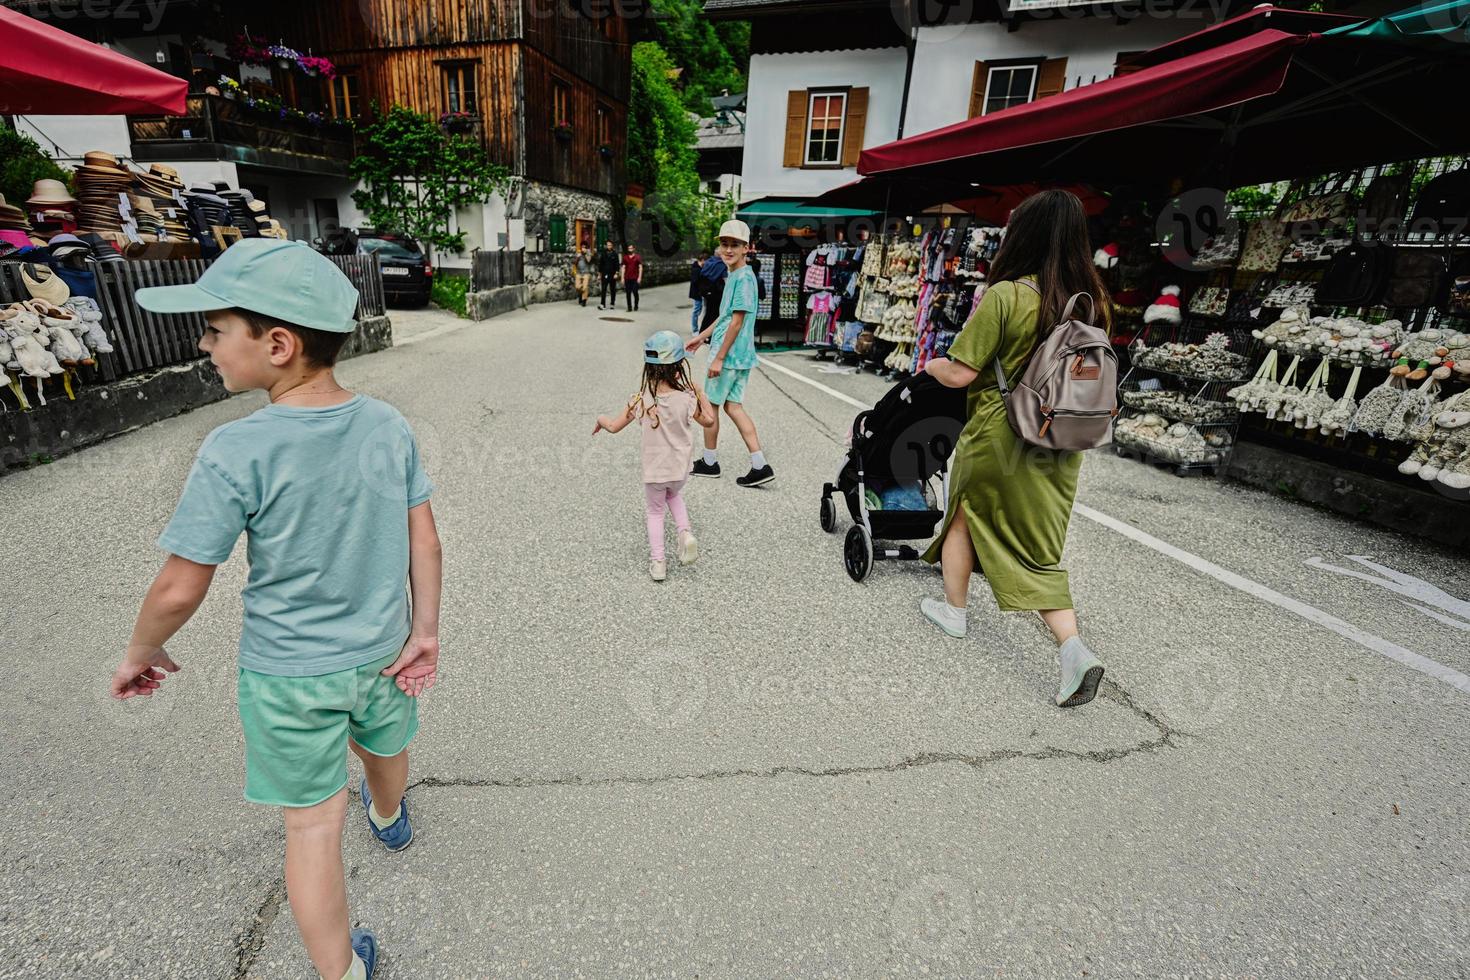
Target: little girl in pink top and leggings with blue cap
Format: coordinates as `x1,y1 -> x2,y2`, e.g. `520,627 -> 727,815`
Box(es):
592,331 -> 714,582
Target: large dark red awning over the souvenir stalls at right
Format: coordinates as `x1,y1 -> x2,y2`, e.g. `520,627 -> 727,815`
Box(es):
857,20 -> 1470,187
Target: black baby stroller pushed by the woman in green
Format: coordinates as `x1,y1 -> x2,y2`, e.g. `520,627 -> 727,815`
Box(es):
822,375 -> 966,582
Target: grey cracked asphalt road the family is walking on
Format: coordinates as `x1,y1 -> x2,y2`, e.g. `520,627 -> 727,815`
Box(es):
0,288 -> 1470,979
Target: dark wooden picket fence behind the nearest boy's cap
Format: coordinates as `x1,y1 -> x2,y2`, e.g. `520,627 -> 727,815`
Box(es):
0,256 -> 385,381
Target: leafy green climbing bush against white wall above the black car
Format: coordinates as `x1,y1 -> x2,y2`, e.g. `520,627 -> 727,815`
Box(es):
351,106 -> 510,251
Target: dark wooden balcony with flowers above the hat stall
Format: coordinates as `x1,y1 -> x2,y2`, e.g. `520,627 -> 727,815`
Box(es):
128,96 -> 357,176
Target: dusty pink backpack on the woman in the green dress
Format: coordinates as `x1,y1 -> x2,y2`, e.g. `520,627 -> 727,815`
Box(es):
995,279 -> 1117,450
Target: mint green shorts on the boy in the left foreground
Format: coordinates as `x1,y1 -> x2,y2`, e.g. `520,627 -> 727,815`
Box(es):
240,654 -> 419,807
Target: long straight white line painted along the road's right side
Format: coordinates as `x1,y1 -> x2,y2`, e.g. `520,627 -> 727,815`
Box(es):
760,357 -> 1470,693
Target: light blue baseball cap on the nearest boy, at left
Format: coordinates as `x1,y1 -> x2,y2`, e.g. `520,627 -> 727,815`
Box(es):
137,238 -> 357,334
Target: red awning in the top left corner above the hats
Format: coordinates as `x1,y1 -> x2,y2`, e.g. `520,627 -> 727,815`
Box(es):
0,7 -> 188,116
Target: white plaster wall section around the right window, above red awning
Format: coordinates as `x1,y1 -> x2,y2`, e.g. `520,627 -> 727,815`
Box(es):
904,10 -> 1211,137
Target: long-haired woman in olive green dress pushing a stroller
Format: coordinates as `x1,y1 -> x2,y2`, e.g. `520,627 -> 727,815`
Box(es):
920,191 -> 1110,707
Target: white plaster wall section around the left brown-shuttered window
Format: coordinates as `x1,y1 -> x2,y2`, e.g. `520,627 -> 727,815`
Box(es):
741,47 -> 905,201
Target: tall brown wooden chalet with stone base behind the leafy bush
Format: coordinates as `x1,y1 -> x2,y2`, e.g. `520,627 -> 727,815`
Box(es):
250,0 -> 647,276
